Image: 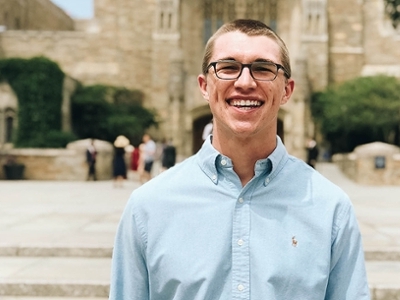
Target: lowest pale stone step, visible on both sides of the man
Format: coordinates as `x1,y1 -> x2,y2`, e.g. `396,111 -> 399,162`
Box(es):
0,256 -> 400,300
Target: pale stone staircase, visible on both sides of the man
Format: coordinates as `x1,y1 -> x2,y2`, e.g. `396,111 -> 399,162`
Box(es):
0,247 -> 400,300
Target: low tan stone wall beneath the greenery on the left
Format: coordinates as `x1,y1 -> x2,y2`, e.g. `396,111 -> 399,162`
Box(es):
0,140 -> 113,181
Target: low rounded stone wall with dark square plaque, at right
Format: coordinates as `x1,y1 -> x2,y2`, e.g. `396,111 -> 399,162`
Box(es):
332,142 -> 400,185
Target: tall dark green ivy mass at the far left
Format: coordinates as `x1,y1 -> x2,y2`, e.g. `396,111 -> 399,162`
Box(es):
0,57 -> 73,148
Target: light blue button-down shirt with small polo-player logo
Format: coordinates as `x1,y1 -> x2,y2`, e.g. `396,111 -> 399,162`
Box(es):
110,138 -> 370,300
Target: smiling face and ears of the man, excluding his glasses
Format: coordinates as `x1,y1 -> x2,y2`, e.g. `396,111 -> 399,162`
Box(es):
198,31 -> 294,138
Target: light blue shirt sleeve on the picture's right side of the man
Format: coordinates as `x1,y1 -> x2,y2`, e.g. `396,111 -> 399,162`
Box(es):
325,203 -> 370,300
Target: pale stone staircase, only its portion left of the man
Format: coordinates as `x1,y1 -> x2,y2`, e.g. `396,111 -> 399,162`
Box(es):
0,247 -> 112,300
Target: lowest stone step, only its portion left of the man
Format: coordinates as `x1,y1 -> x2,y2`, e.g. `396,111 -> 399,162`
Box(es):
0,256 -> 111,300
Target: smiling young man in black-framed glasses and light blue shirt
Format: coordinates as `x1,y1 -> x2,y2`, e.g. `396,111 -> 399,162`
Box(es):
110,20 -> 369,300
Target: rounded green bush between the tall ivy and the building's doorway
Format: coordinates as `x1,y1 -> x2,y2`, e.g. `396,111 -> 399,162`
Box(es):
72,85 -> 157,143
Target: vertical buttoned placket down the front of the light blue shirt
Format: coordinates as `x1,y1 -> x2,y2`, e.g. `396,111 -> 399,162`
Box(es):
232,191 -> 250,300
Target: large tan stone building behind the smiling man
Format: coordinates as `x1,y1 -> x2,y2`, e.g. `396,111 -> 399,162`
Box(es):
0,0 -> 400,158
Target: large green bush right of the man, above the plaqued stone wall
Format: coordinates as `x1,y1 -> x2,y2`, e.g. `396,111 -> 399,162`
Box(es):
311,76 -> 400,153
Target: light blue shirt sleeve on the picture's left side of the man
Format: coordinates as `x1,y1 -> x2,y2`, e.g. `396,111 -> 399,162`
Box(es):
109,203 -> 149,300
